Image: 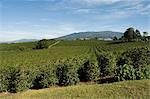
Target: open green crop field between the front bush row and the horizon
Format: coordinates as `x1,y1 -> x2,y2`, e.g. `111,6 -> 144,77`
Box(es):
0,40 -> 150,67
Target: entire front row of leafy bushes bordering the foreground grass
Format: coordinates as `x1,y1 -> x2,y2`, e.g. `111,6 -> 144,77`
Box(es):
0,47 -> 150,93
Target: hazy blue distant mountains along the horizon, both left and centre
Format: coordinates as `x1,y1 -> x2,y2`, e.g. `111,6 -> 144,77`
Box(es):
0,31 -> 123,43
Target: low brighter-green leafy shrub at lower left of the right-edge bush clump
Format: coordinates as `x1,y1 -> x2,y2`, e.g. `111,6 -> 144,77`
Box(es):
116,64 -> 136,81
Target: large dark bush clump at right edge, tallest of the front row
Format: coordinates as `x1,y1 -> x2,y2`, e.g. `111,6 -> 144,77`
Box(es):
116,47 -> 150,80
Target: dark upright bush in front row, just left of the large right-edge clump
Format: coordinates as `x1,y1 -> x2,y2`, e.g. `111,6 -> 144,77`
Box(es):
97,53 -> 116,77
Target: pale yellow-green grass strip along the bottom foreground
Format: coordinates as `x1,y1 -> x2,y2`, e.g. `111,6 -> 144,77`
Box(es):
0,79 -> 150,99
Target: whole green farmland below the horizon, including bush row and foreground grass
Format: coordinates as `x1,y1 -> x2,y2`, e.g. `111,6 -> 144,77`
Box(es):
0,40 -> 150,99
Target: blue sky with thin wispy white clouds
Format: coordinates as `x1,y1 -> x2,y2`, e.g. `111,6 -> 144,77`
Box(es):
0,0 -> 150,41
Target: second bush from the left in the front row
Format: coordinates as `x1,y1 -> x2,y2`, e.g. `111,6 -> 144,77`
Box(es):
32,65 -> 57,89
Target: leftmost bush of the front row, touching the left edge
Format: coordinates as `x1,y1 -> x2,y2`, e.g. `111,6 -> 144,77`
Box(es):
0,66 -> 30,93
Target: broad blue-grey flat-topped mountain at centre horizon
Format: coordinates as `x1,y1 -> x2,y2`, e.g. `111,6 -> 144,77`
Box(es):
57,31 -> 123,40
